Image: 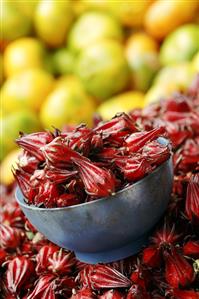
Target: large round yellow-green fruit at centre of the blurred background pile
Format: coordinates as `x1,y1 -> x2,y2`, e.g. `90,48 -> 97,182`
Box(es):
76,40 -> 129,100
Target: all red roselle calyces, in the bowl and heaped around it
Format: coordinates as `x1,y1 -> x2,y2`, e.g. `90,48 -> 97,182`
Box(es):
0,77 -> 199,299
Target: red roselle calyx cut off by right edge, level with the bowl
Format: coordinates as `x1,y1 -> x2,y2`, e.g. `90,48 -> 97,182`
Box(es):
185,173 -> 199,223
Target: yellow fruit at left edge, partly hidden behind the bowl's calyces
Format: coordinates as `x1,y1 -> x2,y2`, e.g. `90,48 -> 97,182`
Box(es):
0,149 -> 22,185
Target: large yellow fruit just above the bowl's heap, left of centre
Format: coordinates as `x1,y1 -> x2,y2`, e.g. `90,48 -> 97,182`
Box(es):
40,76 -> 95,129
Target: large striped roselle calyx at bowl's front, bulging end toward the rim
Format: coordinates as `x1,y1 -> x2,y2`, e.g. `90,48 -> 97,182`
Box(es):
73,158 -> 115,197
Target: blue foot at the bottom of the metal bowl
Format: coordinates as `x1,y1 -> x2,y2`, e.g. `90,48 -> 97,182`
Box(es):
75,233 -> 150,264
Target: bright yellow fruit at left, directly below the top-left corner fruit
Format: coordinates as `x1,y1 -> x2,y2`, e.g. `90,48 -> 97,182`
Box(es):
4,37 -> 45,77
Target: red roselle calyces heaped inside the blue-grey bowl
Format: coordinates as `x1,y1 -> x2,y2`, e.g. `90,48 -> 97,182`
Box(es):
14,113 -> 170,208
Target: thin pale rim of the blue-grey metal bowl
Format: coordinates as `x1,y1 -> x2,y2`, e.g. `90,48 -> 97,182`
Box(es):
15,151 -> 172,212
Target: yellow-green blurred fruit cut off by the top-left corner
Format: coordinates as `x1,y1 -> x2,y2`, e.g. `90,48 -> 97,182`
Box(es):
1,0 -> 31,42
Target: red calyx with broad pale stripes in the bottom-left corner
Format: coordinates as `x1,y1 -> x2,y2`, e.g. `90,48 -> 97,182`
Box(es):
6,256 -> 34,294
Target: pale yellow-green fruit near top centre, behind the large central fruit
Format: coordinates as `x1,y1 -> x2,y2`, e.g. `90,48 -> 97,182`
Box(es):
68,11 -> 122,52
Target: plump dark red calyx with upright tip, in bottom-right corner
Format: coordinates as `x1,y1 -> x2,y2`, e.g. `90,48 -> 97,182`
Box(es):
164,247 -> 195,288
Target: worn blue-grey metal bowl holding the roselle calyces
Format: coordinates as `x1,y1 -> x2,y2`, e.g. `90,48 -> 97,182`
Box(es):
16,138 -> 173,263
